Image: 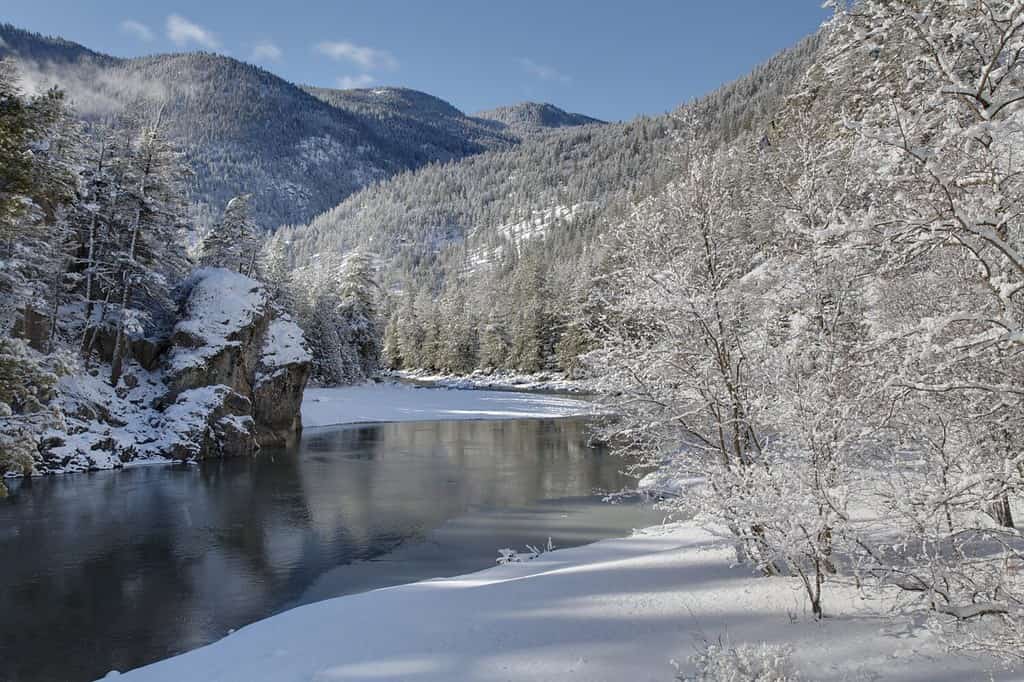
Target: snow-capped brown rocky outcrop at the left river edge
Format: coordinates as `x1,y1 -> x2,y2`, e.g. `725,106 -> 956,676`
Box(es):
34,268 -> 310,473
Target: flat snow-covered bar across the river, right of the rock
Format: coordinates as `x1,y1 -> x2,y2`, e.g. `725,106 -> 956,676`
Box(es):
302,383 -> 596,428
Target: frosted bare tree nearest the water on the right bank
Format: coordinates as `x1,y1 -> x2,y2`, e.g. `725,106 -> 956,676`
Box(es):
594,143 -> 782,574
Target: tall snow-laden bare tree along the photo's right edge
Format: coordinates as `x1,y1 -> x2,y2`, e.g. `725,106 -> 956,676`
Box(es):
825,0 -> 1024,656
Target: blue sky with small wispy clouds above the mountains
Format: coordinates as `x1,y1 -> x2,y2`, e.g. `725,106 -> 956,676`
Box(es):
0,0 -> 827,120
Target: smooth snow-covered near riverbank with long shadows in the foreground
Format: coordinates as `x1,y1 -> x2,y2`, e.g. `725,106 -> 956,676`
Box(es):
108,523 -> 1020,682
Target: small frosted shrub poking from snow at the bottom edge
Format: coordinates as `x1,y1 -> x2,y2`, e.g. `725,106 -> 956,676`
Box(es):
676,641 -> 800,682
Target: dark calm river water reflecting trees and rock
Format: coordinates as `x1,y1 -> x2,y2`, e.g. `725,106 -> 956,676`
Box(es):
0,419 -> 659,682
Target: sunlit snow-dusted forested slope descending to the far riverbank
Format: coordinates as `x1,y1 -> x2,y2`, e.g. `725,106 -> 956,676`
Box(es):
269,36 -> 820,372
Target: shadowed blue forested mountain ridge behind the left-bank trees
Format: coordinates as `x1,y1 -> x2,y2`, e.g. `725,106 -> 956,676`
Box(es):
0,24 -> 598,229
